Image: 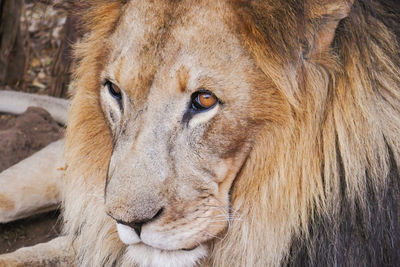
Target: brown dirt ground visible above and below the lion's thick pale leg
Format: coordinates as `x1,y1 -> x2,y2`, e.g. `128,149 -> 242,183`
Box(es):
0,107 -> 64,254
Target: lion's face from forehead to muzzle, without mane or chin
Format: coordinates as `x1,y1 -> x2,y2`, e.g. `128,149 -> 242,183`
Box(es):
100,2 -> 279,255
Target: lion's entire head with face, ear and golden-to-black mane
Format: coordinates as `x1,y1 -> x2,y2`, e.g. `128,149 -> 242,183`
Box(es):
0,0 -> 400,266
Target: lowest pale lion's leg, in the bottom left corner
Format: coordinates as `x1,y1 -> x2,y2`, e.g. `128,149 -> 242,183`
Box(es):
0,236 -> 74,267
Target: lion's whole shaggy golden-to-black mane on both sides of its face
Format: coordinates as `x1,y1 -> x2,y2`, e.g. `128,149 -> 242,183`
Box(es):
64,0 -> 400,266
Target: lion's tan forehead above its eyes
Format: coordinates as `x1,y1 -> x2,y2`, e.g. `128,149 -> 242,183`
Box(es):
106,1 -> 245,96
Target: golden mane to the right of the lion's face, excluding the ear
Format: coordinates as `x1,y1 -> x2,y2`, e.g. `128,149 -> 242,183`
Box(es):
212,1 -> 400,266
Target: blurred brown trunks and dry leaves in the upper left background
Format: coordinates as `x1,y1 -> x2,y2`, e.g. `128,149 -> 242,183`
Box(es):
0,0 -> 79,97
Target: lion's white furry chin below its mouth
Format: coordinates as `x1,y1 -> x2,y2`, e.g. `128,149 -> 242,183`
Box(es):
125,243 -> 208,267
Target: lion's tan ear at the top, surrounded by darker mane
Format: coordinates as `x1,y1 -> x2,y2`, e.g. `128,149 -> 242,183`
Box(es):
307,0 -> 354,56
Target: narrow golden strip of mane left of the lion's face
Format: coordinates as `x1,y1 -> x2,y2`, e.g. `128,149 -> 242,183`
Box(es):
63,0 -> 122,266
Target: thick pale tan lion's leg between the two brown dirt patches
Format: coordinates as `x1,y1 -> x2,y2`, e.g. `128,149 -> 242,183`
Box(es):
0,139 -> 65,223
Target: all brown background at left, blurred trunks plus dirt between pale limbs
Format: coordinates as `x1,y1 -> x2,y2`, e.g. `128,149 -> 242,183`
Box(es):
0,0 -> 80,254
